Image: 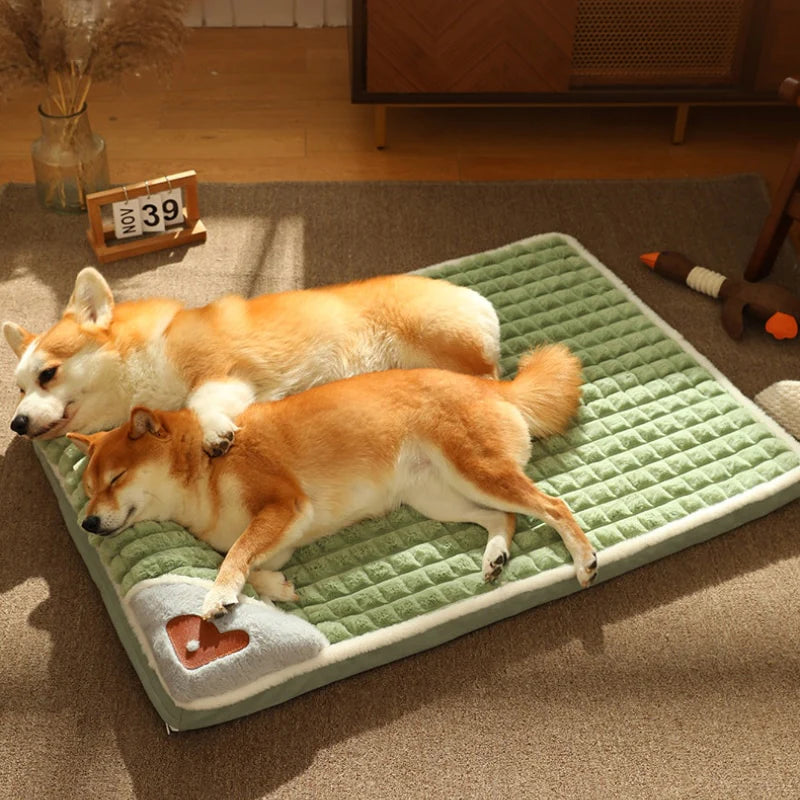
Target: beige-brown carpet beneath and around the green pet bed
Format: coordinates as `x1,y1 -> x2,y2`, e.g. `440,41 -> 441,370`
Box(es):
0,176 -> 800,800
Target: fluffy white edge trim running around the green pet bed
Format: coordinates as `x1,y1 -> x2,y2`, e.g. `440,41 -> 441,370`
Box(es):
115,232 -> 800,711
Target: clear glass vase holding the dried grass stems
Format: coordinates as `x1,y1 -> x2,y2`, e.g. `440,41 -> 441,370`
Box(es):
31,103 -> 109,212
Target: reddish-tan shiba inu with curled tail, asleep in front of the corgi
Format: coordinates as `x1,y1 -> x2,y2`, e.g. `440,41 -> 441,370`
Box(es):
69,345 -> 597,618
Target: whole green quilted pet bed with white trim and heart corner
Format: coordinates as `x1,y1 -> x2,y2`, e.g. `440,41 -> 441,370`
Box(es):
36,234 -> 800,729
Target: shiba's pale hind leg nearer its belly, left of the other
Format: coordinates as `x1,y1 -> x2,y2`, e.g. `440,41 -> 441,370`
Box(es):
403,478 -> 517,582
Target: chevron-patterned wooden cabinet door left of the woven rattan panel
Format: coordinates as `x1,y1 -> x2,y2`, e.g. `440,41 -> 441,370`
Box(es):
365,0 -> 578,94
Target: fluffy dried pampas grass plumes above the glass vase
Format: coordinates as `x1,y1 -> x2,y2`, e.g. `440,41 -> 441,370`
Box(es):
0,0 -> 189,115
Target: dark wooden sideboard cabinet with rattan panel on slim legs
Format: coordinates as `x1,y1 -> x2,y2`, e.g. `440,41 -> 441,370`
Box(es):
348,0 -> 800,147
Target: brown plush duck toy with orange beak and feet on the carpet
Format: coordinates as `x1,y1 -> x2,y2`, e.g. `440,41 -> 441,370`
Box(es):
639,250 -> 800,339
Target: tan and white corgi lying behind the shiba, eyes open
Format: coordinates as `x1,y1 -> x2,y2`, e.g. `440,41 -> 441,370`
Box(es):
3,267 -> 500,455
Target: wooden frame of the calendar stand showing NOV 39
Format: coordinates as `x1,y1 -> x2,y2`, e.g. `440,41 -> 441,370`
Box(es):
86,170 -> 206,264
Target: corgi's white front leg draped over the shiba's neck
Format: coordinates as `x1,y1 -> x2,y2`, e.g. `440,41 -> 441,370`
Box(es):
186,378 -> 255,458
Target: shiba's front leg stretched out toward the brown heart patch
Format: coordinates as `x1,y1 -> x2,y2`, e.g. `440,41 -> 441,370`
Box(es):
201,496 -> 311,619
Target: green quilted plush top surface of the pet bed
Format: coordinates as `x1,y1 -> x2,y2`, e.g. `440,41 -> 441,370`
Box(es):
36,234 -> 800,724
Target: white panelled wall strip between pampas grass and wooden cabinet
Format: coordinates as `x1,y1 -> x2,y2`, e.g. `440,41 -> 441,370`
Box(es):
184,0 -> 349,28
